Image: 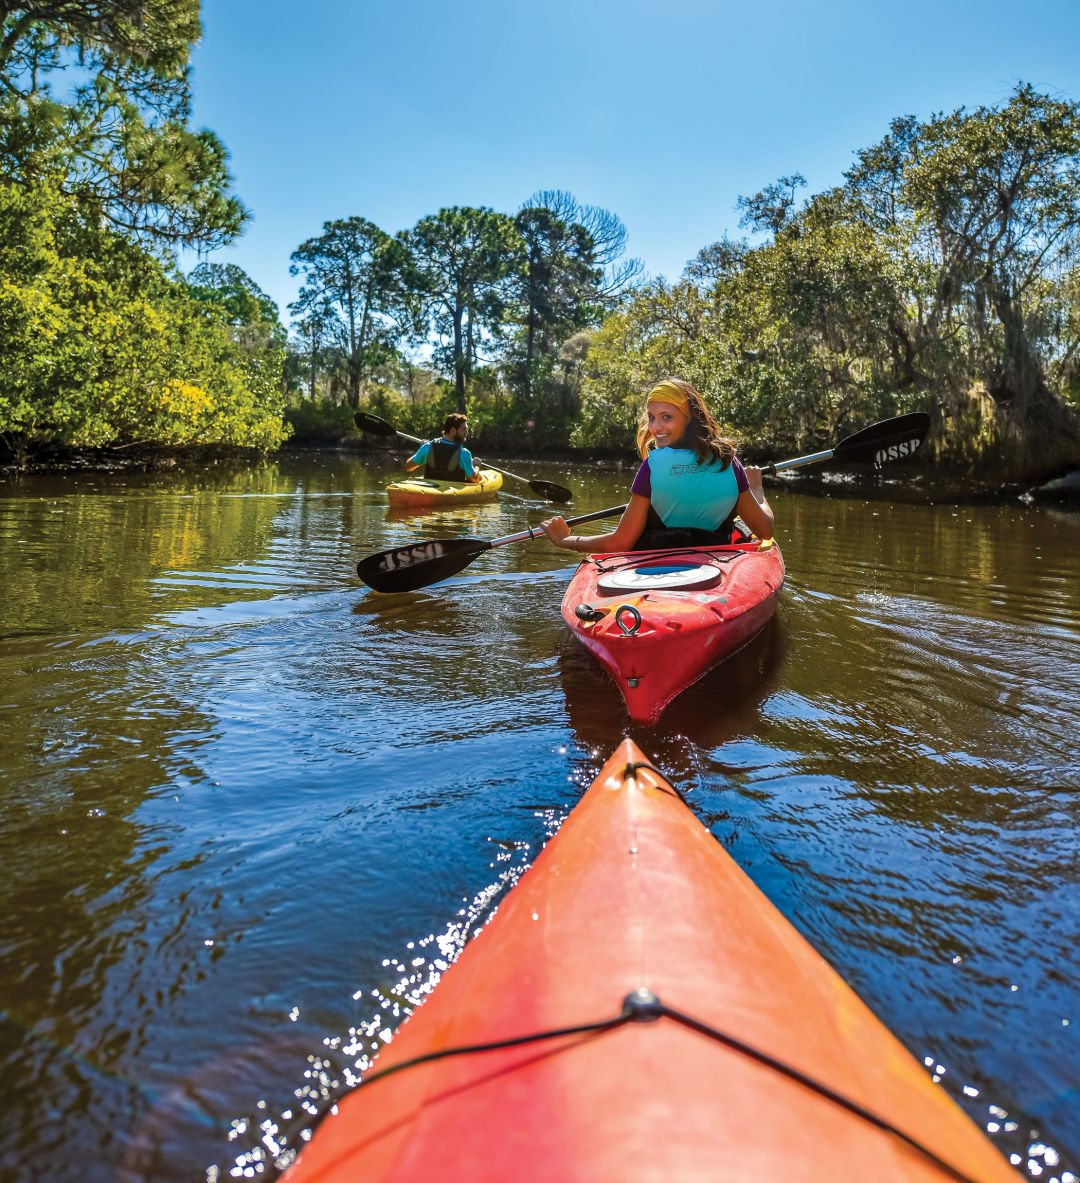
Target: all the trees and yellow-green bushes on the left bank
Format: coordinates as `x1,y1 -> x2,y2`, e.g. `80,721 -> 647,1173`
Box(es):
0,0 -> 285,453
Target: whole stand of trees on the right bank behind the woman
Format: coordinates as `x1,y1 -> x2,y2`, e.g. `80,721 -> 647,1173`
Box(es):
576,85 -> 1080,479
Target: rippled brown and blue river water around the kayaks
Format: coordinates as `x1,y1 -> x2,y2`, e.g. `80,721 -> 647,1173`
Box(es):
0,454 -> 1080,1183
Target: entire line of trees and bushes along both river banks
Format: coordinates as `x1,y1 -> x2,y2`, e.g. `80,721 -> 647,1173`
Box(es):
0,0 -> 1080,490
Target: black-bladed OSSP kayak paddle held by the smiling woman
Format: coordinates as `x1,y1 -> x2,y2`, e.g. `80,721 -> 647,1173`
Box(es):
356,412 -> 930,592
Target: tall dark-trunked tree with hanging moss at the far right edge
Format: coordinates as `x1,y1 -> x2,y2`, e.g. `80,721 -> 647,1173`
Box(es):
847,84 -> 1080,467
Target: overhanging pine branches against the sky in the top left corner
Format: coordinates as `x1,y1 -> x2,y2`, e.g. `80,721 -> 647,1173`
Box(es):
0,0 -> 247,248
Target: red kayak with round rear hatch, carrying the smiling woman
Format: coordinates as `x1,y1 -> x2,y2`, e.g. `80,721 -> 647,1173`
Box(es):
562,538 -> 784,723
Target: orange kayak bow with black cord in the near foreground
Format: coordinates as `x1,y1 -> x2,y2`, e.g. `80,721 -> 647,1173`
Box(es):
286,741 -> 1017,1183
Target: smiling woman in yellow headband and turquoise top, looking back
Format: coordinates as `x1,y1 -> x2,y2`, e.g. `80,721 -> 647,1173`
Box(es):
543,377 -> 774,554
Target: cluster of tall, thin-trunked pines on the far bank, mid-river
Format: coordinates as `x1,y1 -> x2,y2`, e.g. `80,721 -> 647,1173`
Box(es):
291,190 -> 641,444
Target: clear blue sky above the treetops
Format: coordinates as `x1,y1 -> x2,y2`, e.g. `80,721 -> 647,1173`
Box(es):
182,0 -> 1080,333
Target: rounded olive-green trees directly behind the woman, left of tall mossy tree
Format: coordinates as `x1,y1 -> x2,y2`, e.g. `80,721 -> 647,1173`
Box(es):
578,192 -> 921,454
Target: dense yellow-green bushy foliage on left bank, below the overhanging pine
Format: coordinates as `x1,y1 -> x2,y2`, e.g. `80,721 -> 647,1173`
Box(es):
0,181 -> 284,453
